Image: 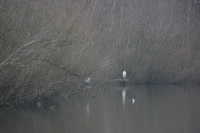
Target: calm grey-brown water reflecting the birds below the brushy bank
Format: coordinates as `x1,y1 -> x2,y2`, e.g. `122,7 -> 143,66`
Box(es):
0,85 -> 200,133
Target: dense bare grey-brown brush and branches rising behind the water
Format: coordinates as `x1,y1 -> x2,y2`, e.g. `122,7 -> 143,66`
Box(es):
0,0 -> 200,104
